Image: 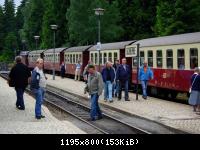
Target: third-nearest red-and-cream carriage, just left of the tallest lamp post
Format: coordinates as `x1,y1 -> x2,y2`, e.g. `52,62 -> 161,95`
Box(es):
64,46 -> 91,75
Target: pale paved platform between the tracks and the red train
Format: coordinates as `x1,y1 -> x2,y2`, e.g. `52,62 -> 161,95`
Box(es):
47,75 -> 200,134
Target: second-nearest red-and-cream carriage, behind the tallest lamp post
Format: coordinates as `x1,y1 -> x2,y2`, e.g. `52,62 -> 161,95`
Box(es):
89,41 -> 135,70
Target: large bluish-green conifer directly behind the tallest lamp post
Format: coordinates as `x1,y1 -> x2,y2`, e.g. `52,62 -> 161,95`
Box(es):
67,0 -> 123,45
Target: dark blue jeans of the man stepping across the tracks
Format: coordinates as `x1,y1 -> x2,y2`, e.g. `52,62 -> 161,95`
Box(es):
90,93 -> 102,120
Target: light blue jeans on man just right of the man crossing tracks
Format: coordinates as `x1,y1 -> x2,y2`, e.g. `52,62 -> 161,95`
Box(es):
104,81 -> 113,101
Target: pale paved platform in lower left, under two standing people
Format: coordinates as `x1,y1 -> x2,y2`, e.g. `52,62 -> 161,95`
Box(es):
0,77 -> 85,134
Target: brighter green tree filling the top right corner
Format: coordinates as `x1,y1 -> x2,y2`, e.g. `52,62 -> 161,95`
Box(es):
154,0 -> 200,36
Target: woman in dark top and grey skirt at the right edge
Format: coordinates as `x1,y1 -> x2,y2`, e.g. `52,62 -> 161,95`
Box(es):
189,67 -> 200,112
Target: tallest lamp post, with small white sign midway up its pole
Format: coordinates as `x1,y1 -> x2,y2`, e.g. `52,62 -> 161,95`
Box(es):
94,8 -> 105,72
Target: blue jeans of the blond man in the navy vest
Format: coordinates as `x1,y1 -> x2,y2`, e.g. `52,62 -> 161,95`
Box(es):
34,87 -> 45,116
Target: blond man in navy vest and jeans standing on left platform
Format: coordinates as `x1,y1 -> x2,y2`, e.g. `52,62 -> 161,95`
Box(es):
30,58 -> 47,119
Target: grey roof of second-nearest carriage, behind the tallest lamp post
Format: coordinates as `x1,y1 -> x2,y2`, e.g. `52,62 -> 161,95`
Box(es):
89,40 -> 135,51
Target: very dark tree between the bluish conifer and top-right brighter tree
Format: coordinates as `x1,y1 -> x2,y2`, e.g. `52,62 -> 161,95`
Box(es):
117,0 -> 157,40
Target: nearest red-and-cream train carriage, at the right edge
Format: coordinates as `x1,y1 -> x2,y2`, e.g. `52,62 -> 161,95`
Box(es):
126,32 -> 200,97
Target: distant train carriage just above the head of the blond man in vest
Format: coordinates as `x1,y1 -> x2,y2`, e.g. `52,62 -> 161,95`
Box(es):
28,50 -> 45,69
